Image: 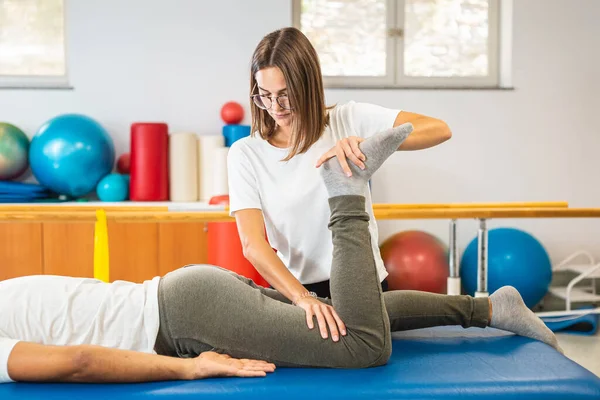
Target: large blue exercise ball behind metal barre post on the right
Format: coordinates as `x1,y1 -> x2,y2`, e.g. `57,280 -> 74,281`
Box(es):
460,228 -> 552,308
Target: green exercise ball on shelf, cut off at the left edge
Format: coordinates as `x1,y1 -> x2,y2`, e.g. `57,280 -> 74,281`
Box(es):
0,122 -> 29,180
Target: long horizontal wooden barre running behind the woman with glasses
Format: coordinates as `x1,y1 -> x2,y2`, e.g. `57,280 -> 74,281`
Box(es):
0,207 -> 600,222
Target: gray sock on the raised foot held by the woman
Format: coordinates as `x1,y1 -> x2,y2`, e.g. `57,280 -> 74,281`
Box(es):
321,123 -> 413,197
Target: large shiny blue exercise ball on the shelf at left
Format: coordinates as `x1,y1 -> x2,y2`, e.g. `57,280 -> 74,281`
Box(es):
29,114 -> 115,197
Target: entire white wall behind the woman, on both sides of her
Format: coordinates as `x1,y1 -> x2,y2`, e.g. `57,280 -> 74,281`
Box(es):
0,0 -> 600,266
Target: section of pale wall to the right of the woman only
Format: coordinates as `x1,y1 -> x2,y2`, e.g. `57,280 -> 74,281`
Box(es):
366,0 -> 600,266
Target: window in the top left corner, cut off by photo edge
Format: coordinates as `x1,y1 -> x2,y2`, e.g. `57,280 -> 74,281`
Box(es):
0,0 -> 67,87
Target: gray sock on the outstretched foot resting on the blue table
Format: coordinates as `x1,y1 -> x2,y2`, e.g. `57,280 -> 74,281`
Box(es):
490,286 -> 564,353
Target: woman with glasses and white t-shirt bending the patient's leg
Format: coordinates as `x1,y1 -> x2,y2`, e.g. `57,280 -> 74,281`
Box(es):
228,28 -> 451,336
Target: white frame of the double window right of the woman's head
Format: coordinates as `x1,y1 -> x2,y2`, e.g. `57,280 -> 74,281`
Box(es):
292,0 -> 506,89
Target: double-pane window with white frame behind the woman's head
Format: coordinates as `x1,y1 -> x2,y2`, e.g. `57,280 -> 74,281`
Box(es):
293,0 -> 500,87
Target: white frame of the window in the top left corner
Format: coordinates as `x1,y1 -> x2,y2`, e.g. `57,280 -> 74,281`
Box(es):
0,0 -> 69,89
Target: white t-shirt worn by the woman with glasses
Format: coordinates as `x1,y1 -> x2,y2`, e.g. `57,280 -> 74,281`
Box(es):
227,102 -> 400,284
